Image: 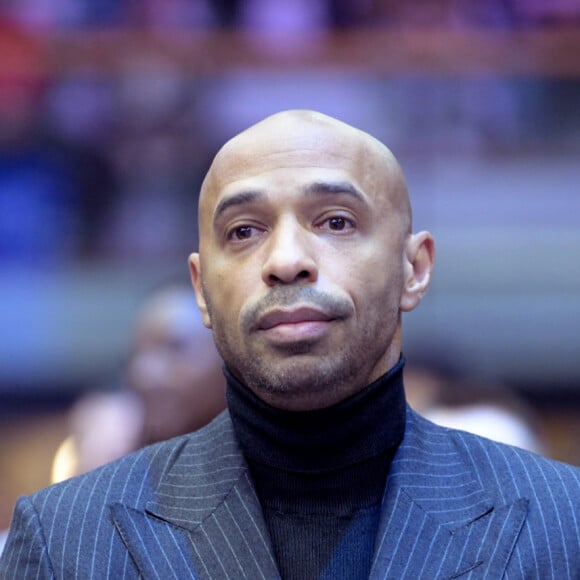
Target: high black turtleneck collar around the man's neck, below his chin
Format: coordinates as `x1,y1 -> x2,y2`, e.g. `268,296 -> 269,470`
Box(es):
225,358 -> 405,472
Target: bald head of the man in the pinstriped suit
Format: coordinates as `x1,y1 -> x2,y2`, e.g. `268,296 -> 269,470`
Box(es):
190,111 -> 433,410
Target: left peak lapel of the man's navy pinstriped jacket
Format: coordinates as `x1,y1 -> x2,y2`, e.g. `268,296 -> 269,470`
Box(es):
112,414 -> 279,579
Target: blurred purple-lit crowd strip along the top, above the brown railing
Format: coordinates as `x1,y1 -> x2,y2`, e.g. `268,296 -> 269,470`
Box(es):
4,0 -> 580,30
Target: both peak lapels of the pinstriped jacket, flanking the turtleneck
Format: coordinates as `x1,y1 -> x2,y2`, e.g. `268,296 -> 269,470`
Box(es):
112,411 -> 527,578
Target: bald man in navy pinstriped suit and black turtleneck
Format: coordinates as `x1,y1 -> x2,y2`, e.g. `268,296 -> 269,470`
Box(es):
0,111 -> 580,579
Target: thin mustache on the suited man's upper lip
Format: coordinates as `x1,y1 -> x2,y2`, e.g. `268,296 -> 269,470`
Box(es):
241,286 -> 353,331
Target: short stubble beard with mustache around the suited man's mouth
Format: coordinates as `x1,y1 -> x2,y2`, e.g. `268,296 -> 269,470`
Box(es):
205,286 -> 400,408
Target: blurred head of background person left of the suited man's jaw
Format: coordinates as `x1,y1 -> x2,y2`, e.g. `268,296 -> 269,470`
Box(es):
127,286 -> 225,443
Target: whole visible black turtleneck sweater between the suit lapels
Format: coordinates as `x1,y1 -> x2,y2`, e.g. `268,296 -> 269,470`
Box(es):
225,358 -> 405,580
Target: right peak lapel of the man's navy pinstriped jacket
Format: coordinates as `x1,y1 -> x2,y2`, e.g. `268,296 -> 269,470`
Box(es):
371,412 -> 527,578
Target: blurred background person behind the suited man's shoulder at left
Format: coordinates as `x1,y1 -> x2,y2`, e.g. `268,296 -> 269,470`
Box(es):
52,286 -> 226,482
